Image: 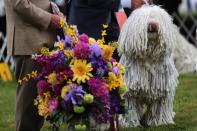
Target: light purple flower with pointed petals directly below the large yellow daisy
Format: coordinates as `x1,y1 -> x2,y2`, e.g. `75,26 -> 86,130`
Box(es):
64,84 -> 86,105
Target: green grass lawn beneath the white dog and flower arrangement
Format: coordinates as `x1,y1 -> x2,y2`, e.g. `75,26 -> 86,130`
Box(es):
0,74 -> 197,131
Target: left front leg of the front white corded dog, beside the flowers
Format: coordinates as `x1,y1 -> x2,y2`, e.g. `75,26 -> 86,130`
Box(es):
119,97 -> 140,128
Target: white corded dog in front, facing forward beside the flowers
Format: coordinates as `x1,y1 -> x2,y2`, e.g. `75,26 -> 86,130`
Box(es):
119,5 -> 178,127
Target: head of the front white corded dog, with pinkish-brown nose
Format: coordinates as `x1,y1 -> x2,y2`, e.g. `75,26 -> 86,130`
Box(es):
119,5 -> 176,57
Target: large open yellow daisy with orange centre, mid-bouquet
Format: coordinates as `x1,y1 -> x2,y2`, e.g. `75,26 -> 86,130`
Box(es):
70,59 -> 93,84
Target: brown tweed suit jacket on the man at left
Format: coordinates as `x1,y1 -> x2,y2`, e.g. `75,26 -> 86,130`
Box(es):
5,0 -> 55,55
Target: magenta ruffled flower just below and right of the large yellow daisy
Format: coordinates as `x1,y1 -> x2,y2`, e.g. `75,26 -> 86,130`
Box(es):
88,78 -> 109,97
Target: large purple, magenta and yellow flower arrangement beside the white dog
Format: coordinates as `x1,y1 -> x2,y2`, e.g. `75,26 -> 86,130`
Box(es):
20,19 -> 126,131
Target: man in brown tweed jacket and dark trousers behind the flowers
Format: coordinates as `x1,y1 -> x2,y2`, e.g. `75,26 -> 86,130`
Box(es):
5,0 -> 60,131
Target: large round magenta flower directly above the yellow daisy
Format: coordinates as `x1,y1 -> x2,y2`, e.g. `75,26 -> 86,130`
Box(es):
74,42 -> 91,59
